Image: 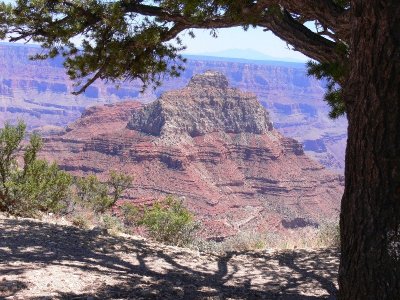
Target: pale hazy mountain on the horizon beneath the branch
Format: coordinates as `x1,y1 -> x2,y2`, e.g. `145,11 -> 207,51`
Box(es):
191,49 -> 304,63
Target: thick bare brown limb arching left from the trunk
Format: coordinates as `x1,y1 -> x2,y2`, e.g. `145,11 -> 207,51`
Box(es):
123,0 -> 346,62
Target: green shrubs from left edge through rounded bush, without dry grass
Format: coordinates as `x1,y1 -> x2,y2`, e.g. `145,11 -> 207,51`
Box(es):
0,122 -> 198,246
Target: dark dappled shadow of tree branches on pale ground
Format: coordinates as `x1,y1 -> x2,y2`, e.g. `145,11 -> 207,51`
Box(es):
0,219 -> 337,300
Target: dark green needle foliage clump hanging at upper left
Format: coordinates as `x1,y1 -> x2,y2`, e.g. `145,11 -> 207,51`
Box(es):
0,0 -> 184,93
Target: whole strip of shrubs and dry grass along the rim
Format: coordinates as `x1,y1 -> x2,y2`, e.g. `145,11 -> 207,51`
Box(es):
0,122 -> 339,252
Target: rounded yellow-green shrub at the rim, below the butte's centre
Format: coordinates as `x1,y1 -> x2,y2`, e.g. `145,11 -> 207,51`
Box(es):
138,196 -> 198,246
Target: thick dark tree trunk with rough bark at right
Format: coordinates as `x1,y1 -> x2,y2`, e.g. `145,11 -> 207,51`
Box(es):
339,0 -> 400,300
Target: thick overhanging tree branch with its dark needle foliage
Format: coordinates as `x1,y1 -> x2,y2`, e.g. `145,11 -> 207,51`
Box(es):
0,0 -> 349,92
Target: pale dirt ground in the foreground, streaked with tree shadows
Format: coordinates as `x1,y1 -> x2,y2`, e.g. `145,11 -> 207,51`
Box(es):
0,215 -> 339,300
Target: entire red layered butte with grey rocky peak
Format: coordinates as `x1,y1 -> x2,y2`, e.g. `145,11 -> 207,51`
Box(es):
42,72 -> 343,237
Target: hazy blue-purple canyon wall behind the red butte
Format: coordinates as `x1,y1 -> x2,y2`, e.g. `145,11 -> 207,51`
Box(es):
0,43 -> 347,174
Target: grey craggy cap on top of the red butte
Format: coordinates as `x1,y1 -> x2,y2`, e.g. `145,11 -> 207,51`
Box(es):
128,71 -> 272,138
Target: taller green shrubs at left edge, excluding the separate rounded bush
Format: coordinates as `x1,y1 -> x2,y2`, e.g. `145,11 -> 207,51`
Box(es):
0,121 -> 133,219
